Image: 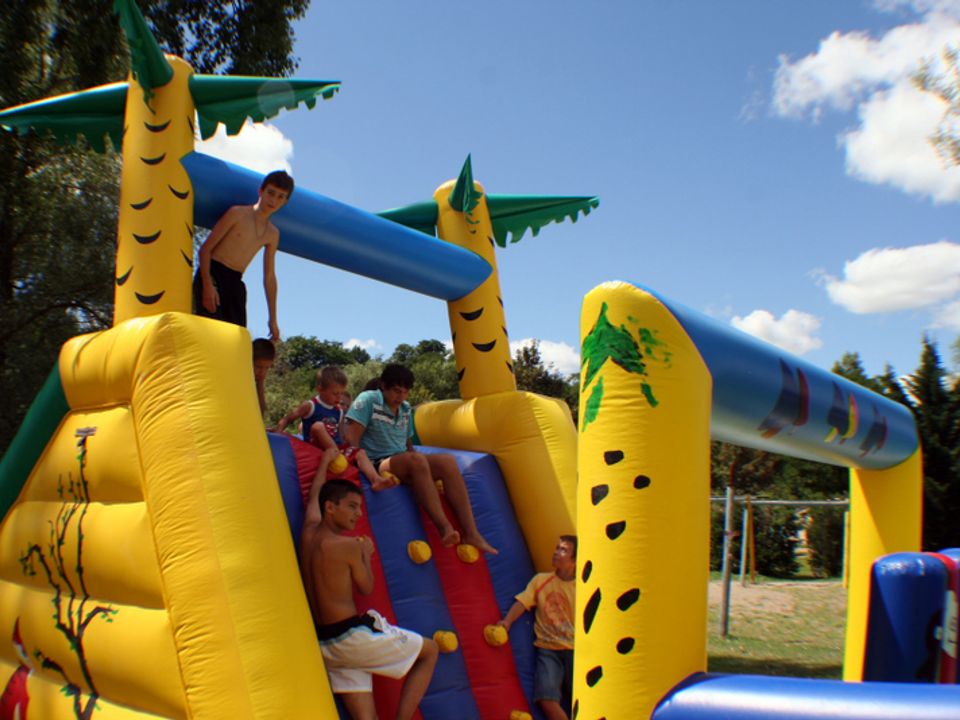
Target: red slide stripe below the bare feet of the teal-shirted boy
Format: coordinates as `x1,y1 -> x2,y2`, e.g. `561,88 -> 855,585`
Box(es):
420,506 -> 530,718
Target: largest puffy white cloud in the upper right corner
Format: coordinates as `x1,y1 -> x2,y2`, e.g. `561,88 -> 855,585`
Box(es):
773,0 -> 960,202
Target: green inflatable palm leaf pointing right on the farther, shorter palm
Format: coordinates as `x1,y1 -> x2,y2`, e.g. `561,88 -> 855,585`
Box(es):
487,195 -> 600,247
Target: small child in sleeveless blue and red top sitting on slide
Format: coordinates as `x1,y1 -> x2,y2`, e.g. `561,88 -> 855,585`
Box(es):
273,365 -> 399,490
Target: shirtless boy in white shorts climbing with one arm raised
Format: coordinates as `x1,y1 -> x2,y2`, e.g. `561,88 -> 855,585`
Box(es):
300,470 -> 438,720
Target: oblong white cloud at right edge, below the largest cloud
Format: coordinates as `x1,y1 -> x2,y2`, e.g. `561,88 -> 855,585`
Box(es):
822,240 -> 960,314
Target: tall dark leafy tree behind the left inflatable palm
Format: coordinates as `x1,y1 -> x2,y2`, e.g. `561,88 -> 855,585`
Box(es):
0,0 -> 309,452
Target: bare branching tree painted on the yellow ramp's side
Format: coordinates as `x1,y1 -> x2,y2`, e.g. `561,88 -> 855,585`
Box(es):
20,427 -> 118,720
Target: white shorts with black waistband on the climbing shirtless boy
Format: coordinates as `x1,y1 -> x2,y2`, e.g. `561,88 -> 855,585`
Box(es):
320,610 -> 423,693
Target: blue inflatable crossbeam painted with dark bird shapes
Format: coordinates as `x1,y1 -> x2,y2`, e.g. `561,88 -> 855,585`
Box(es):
635,283 -> 918,470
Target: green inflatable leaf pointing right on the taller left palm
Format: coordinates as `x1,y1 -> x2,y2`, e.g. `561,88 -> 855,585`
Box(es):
190,75 -> 340,140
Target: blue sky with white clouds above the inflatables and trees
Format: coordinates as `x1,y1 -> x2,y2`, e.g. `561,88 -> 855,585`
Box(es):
200,0 -> 960,374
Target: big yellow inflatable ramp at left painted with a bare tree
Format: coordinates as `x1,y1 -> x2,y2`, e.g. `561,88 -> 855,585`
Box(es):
0,313 -> 337,719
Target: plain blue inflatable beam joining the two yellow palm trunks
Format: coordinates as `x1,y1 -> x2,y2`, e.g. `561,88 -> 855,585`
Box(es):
182,152 -> 491,300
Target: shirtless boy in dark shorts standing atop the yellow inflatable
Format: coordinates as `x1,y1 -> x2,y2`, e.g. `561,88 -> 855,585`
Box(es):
193,170 -> 293,342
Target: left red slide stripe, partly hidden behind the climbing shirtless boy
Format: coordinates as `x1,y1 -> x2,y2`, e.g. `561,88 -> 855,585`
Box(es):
290,438 -> 423,720
